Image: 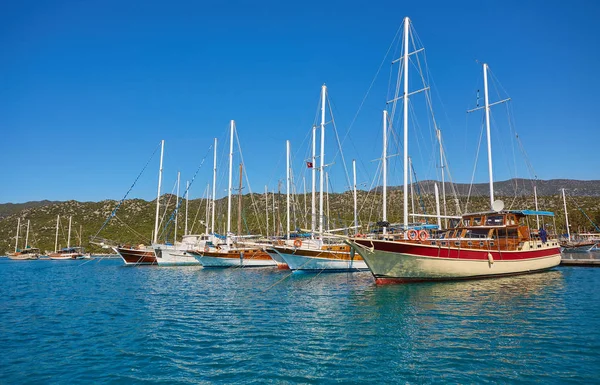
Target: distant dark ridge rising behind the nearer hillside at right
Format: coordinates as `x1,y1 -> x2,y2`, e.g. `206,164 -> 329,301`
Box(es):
382,178 -> 600,197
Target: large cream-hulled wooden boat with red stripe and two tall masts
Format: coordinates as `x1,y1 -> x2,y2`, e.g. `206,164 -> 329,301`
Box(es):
347,18 -> 561,283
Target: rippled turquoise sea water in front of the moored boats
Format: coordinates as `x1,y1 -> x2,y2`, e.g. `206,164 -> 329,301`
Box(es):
0,254 -> 600,384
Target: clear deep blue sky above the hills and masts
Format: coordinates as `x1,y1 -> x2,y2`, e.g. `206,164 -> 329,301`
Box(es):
0,0 -> 600,202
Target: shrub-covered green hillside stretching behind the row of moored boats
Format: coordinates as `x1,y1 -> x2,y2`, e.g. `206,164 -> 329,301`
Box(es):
0,180 -> 600,255
